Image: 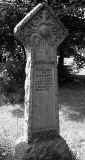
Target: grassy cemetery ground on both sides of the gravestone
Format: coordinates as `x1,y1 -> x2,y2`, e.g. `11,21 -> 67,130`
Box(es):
0,64 -> 85,160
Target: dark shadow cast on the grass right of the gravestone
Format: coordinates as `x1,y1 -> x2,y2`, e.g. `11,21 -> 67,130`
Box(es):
59,79 -> 85,121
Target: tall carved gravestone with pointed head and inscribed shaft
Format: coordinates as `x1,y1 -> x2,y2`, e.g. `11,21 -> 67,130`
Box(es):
14,4 -> 68,160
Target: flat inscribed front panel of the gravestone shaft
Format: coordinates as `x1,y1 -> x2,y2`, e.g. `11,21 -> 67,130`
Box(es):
32,64 -> 59,131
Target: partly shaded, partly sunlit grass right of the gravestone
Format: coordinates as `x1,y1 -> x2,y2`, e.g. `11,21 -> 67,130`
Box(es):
59,83 -> 85,160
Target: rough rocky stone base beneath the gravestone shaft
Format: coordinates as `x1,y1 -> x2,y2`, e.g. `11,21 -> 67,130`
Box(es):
14,136 -> 75,160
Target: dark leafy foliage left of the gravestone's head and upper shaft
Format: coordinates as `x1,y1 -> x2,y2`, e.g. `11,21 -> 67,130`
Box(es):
0,2 -> 26,87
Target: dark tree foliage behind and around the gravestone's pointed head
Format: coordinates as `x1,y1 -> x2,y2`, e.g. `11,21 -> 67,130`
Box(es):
0,0 -> 85,87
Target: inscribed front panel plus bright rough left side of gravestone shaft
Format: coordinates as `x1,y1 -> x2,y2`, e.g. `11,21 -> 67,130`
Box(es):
24,47 -> 59,139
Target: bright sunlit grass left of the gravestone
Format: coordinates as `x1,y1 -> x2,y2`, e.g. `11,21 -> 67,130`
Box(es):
0,104 -> 24,160
